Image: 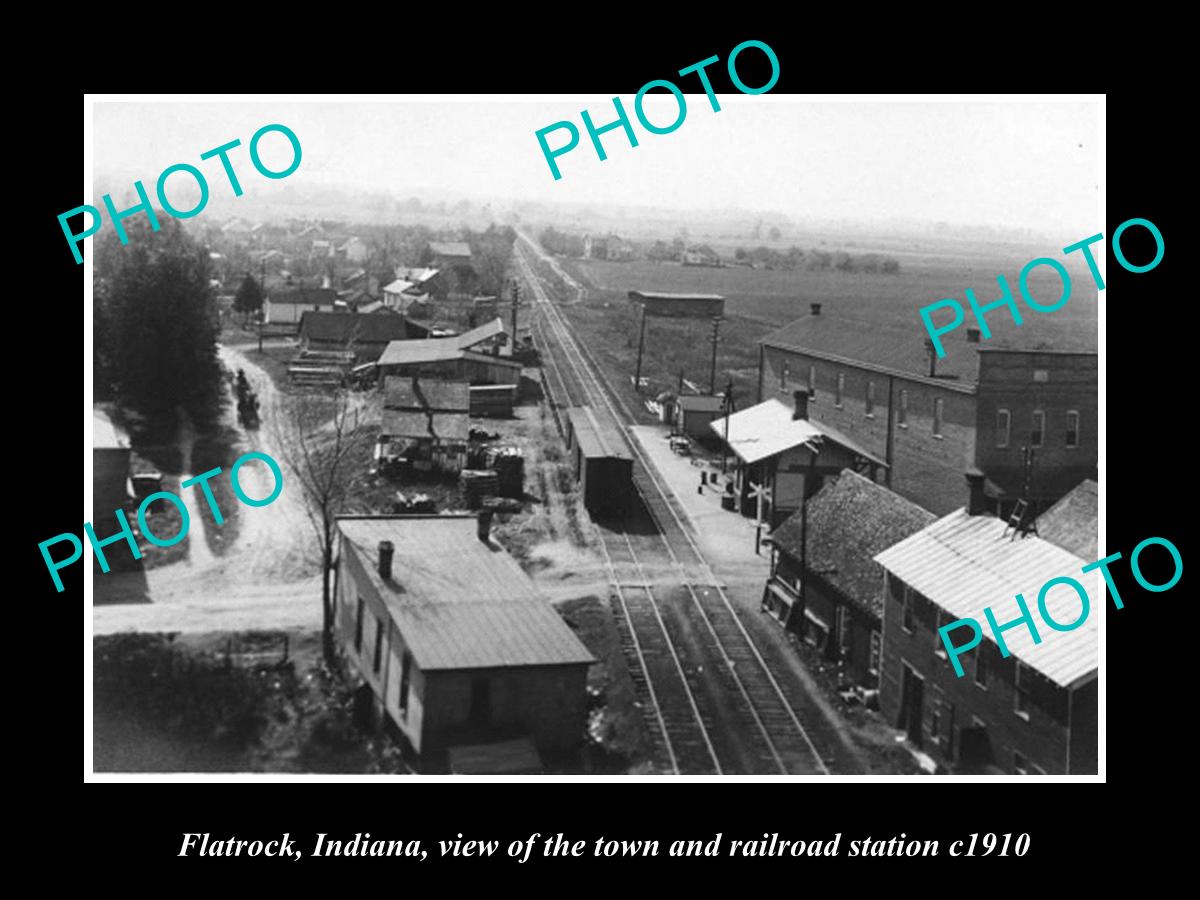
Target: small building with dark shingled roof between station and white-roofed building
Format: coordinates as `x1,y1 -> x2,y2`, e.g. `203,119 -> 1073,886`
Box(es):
763,469 -> 935,689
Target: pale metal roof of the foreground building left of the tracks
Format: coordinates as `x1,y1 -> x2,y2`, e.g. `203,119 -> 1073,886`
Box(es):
337,516 -> 595,671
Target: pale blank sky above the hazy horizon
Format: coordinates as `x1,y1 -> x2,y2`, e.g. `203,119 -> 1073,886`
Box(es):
92,97 -> 1103,241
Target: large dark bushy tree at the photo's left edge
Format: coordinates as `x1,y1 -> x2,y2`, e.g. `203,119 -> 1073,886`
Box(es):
95,215 -> 221,420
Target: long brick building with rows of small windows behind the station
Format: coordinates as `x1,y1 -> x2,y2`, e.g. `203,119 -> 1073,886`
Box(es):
758,304 -> 1099,515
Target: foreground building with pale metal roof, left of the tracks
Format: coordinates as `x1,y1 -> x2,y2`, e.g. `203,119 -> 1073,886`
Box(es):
334,512 -> 595,772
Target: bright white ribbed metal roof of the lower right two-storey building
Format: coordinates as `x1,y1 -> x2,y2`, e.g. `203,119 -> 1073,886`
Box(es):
875,509 -> 1104,686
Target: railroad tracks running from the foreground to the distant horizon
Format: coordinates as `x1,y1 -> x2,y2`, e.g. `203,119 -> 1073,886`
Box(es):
515,238 -> 842,775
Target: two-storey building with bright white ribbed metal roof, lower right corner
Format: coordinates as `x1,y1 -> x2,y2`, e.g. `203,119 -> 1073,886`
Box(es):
875,476 -> 1103,775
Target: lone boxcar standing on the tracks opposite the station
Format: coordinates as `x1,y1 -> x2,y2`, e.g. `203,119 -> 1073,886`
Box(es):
566,407 -> 634,516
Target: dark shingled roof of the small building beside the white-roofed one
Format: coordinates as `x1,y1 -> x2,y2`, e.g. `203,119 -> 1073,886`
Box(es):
770,469 -> 936,617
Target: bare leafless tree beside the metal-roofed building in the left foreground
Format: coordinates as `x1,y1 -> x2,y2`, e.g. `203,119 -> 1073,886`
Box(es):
275,386 -> 370,662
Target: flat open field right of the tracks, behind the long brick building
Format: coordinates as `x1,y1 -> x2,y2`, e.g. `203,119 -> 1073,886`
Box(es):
559,244 -> 1103,422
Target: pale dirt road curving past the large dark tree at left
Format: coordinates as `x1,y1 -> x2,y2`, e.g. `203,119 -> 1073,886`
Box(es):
92,347 -> 320,634
